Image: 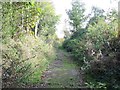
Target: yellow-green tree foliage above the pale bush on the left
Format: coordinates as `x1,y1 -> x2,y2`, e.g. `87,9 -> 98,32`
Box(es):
2,2 -> 59,38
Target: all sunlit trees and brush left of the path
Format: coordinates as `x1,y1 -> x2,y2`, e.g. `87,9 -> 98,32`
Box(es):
0,2 -> 59,88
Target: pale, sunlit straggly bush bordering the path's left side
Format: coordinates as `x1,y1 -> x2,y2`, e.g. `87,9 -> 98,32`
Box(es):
2,34 -> 56,87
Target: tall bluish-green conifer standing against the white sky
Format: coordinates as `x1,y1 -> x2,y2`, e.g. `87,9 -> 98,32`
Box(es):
67,0 -> 85,31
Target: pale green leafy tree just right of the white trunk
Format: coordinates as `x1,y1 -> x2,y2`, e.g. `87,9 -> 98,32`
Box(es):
37,2 -> 59,38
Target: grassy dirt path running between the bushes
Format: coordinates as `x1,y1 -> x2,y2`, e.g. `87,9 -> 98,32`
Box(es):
36,50 -> 83,88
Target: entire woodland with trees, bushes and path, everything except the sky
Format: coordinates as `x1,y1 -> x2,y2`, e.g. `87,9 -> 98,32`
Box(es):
0,0 -> 120,90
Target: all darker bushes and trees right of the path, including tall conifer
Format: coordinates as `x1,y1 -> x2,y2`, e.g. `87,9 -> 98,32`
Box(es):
63,0 -> 120,88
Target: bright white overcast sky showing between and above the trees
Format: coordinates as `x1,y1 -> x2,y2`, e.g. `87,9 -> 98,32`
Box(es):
52,0 -> 120,38
